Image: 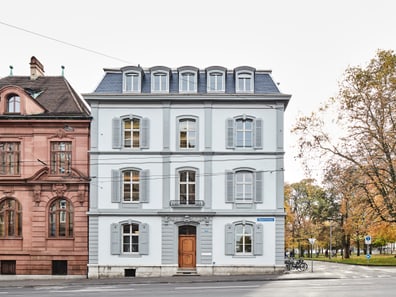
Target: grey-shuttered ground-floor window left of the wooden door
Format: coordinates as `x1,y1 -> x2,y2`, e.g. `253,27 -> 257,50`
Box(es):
110,220 -> 149,256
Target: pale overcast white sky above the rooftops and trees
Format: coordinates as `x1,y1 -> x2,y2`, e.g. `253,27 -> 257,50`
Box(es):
0,0 -> 396,182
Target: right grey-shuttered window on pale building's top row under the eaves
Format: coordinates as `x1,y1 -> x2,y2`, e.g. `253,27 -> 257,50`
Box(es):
226,115 -> 263,149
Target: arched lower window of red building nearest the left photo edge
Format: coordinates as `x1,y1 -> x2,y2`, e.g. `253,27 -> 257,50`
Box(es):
0,198 -> 22,237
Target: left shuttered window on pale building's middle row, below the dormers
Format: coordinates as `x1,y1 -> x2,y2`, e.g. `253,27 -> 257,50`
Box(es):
111,169 -> 149,202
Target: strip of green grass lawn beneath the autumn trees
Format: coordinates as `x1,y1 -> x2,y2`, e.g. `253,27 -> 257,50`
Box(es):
312,254 -> 396,266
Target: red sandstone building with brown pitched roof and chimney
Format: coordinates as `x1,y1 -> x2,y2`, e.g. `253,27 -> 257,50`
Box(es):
0,57 -> 91,279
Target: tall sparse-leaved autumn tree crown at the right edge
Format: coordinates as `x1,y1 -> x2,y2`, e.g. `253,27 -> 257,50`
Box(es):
293,50 -> 396,222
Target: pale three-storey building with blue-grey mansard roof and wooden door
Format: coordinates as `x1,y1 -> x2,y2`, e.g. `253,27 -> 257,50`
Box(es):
83,66 -> 291,278
